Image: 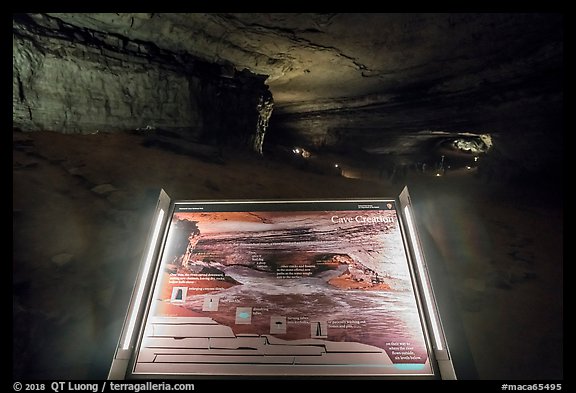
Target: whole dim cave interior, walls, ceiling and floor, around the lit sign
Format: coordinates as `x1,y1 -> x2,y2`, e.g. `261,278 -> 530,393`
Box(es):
13,13 -> 565,379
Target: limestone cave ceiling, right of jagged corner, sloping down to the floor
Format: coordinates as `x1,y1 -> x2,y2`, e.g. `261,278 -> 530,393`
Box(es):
40,13 -> 563,167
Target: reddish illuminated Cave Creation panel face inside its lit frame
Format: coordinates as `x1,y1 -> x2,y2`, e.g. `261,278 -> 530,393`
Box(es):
133,201 -> 433,375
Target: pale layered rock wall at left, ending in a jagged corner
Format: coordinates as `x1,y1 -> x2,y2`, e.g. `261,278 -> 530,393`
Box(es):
12,14 -> 273,152
